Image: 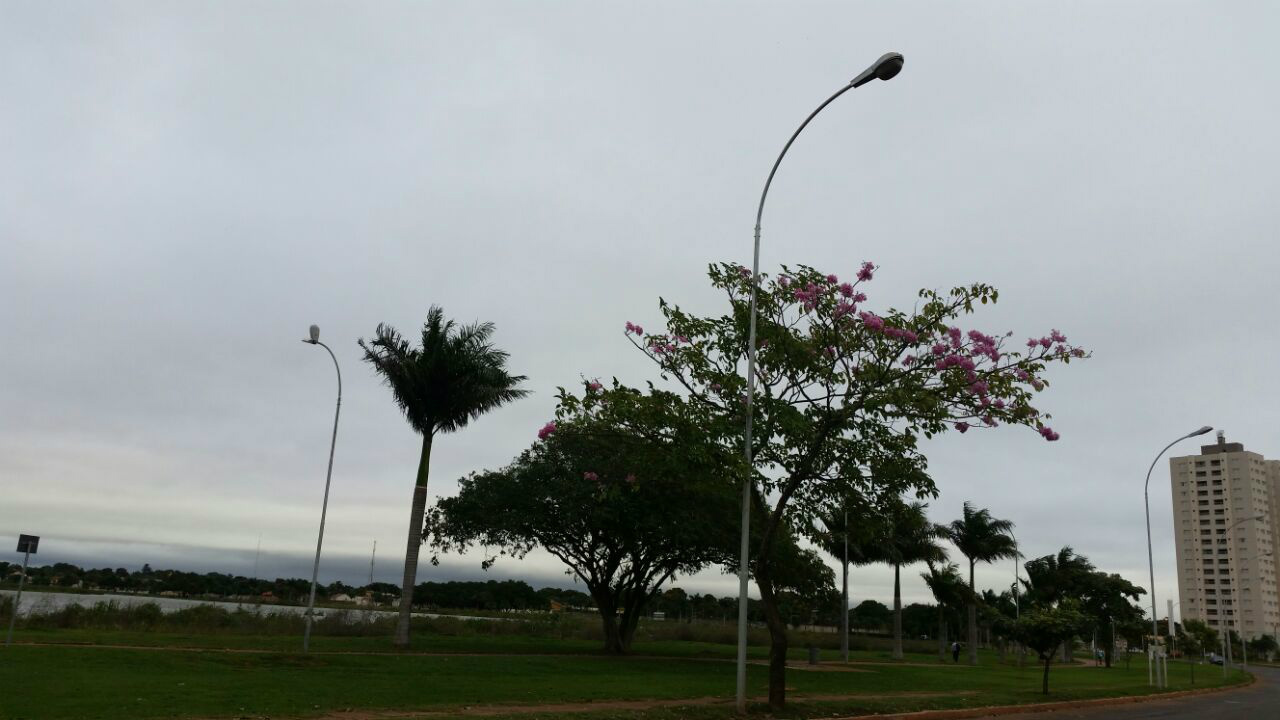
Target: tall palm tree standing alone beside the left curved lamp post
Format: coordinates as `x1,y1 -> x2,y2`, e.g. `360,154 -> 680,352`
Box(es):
360,305 -> 529,647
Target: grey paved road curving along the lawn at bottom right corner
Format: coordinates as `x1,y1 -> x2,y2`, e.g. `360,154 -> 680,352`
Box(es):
1002,666 -> 1280,720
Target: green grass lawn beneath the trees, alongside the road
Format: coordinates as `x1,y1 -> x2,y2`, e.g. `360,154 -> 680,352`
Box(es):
0,630 -> 1242,720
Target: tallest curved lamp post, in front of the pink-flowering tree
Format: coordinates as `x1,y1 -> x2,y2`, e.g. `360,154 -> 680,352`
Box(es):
736,53 -> 902,714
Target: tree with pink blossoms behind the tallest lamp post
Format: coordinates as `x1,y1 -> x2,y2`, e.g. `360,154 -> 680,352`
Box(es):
625,263 -> 1087,708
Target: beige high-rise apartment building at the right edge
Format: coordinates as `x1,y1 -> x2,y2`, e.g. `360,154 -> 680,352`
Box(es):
1169,430 -> 1280,639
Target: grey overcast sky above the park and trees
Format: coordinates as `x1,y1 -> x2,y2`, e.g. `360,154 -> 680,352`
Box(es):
0,1 -> 1280,617
